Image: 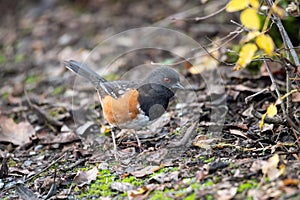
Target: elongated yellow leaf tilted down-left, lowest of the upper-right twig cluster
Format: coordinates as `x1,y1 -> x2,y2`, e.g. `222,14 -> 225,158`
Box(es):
234,43 -> 257,70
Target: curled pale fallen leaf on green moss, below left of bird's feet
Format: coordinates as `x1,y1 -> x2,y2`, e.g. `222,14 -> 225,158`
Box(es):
74,167 -> 98,187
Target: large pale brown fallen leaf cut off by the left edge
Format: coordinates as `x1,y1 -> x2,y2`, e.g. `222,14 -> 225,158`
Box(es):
0,116 -> 35,145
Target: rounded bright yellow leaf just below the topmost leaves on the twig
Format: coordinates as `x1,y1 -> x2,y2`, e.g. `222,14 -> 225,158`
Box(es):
240,8 -> 260,30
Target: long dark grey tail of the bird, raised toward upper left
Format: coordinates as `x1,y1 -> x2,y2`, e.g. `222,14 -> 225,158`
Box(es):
64,60 -> 107,86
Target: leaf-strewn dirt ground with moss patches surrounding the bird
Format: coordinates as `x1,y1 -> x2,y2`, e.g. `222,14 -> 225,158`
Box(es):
0,0 -> 300,199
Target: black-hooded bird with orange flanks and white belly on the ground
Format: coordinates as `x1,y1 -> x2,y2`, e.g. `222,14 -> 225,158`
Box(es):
64,60 -> 184,158
